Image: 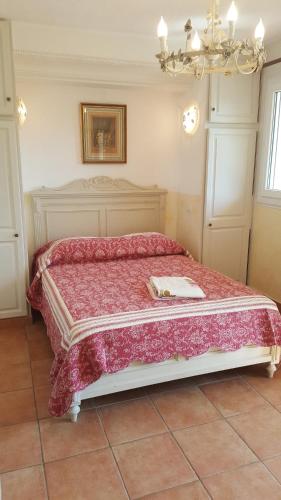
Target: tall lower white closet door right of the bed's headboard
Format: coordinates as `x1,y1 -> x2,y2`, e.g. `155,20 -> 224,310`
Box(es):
203,128 -> 256,282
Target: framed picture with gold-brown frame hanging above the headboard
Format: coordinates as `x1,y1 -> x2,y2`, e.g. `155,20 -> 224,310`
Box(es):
81,103 -> 127,163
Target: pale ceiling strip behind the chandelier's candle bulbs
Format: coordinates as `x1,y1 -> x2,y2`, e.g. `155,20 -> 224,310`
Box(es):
0,0 -> 281,41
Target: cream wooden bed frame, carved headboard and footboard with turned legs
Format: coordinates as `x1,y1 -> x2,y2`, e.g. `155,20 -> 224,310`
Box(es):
32,177 -> 280,422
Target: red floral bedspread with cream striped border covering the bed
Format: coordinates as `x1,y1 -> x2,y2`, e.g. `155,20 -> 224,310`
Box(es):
28,233 -> 281,416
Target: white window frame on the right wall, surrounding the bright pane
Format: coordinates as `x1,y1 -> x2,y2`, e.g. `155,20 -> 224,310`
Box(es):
256,64 -> 281,208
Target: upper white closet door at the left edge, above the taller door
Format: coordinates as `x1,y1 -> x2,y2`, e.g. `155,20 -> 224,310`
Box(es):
0,20 -> 15,116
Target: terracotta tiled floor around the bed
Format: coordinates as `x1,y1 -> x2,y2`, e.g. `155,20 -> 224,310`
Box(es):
0,320 -> 281,500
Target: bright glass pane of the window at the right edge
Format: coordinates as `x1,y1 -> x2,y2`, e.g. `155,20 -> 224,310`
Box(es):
265,90 -> 281,191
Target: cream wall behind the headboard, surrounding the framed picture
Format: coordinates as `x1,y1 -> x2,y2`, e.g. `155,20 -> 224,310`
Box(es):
17,80 -> 185,258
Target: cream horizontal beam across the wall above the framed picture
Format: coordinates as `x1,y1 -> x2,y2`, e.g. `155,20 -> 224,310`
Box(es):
14,50 -> 192,92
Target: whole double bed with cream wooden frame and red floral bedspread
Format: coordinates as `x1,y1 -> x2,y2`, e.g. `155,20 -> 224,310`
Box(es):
28,177 -> 281,422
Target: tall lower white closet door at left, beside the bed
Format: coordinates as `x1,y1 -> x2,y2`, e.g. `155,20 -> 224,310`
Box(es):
0,120 -> 26,318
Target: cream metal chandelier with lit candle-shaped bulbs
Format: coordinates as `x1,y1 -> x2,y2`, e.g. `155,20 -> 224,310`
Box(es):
156,0 -> 266,79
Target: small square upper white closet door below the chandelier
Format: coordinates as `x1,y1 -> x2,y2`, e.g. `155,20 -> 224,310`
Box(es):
209,73 -> 260,124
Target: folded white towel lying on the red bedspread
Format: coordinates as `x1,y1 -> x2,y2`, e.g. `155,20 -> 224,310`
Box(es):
149,276 -> 206,299
